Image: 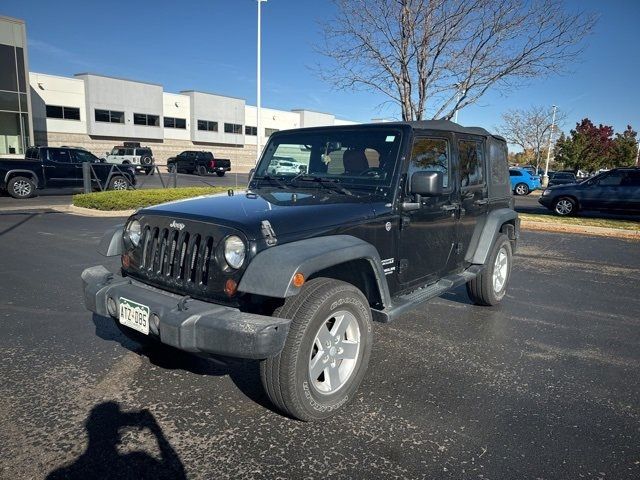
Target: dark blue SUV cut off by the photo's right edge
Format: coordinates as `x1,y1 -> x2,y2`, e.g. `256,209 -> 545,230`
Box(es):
538,167 -> 640,216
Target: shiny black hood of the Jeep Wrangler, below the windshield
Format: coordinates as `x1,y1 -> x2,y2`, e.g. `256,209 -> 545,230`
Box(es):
139,190 -> 385,241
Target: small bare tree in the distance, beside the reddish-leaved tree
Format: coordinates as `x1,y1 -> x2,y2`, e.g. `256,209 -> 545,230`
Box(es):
496,106 -> 567,168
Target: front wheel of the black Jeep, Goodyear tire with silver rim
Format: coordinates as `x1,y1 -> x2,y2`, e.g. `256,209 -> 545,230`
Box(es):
260,278 -> 373,421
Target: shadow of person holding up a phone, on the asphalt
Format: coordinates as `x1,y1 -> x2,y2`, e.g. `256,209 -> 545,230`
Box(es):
47,402 -> 187,480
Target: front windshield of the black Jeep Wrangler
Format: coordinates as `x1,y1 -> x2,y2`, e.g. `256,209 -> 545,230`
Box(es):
254,128 -> 401,187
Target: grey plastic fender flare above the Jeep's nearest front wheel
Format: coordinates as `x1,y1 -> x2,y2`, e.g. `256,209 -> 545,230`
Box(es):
238,235 -> 391,305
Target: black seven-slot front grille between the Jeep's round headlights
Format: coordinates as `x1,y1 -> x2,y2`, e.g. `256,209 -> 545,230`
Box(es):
140,225 -> 214,287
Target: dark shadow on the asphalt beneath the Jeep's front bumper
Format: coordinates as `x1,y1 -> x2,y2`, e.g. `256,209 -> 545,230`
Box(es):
92,313 -> 276,412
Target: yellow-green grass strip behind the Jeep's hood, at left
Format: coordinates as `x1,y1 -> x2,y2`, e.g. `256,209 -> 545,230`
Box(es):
72,187 -> 229,211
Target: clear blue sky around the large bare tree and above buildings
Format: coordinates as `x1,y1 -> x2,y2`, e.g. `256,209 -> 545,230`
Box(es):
0,0 -> 640,136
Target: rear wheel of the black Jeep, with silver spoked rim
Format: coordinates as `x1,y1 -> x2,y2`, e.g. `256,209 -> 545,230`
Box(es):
467,233 -> 513,306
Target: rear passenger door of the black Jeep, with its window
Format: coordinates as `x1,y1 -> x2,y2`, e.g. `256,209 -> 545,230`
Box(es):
456,135 -> 489,264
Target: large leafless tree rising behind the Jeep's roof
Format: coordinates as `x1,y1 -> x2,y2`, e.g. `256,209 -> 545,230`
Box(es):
320,0 -> 596,120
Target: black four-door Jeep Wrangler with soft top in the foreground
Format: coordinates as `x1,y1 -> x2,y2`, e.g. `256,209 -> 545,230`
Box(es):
82,121 -> 519,420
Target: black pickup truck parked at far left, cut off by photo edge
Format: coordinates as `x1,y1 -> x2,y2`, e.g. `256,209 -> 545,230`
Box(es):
0,147 -> 136,198
